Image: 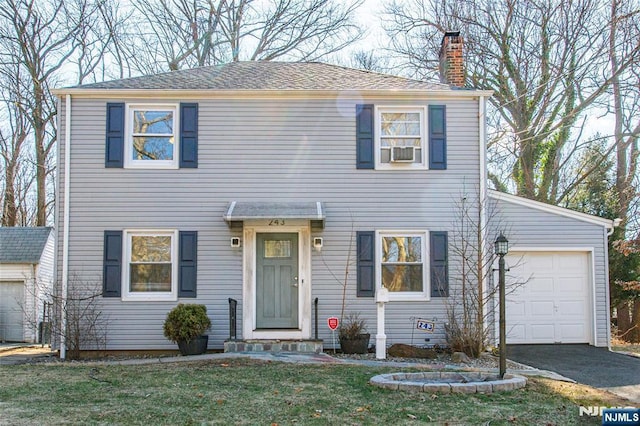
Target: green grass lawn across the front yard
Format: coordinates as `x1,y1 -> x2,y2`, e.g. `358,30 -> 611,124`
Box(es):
0,359 -> 623,425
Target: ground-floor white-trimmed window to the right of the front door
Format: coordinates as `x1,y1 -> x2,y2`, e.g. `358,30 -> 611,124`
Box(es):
376,231 -> 429,301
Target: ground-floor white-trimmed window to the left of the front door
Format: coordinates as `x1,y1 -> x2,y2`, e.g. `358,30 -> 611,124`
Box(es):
122,230 -> 178,300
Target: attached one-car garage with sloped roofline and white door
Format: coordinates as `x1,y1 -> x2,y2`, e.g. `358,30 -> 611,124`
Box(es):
488,191 -> 615,346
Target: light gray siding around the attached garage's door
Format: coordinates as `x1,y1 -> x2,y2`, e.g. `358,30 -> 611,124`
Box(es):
490,198 -> 609,346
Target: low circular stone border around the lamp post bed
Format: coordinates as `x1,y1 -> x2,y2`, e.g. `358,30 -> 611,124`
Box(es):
369,371 -> 527,393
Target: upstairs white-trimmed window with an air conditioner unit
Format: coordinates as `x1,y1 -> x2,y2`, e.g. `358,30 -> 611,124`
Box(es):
375,106 -> 427,169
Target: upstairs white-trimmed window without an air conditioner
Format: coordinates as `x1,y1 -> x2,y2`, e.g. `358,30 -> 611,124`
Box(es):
125,105 -> 178,168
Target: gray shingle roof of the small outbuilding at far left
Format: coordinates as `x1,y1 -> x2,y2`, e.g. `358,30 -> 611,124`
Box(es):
0,227 -> 51,263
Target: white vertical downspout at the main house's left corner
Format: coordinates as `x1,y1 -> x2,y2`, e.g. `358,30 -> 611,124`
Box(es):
60,95 -> 71,360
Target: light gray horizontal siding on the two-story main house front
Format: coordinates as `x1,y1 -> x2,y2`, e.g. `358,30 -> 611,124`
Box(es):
56,98 -> 480,350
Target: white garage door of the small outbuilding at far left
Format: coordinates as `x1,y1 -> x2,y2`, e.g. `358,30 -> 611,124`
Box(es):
0,281 -> 24,342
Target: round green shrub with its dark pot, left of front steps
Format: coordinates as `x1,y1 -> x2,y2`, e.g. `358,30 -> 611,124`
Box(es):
163,303 -> 211,355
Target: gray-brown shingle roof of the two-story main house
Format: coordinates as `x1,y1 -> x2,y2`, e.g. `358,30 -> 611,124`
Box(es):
73,61 -> 450,91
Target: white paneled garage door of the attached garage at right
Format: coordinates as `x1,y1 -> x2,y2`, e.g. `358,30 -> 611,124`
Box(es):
506,252 -> 592,344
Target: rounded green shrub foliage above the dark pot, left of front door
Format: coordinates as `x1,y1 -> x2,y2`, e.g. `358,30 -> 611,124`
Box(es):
163,303 -> 211,343
